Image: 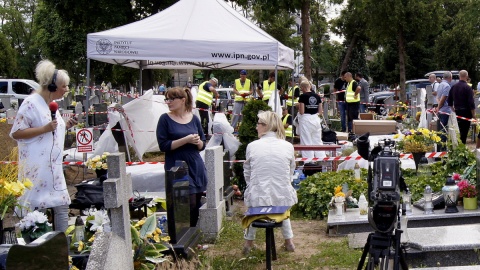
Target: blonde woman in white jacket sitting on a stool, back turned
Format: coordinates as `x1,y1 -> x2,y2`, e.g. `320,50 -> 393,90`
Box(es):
243,111 -> 297,253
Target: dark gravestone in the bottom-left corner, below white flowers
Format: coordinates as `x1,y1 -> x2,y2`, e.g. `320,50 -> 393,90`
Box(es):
5,232 -> 68,270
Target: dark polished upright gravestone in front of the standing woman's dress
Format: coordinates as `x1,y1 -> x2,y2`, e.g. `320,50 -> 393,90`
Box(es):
165,161 -> 200,257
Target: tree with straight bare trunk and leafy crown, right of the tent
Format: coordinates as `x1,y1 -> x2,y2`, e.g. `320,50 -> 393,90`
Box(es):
363,0 -> 445,100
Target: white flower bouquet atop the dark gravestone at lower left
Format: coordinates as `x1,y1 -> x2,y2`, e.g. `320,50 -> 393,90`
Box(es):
16,210 -> 52,244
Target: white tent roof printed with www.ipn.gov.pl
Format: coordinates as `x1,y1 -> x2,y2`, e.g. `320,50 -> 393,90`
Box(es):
87,0 -> 294,69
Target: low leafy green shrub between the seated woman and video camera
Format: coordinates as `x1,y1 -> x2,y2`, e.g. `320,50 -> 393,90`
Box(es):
293,169 -> 367,219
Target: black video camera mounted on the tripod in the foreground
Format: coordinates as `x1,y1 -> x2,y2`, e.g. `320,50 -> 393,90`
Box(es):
357,132 -> 408,233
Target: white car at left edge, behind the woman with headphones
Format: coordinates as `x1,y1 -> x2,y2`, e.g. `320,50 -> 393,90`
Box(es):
0,79 -> 40,106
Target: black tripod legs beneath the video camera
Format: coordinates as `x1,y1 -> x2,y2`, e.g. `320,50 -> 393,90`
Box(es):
357,229 -> 408,270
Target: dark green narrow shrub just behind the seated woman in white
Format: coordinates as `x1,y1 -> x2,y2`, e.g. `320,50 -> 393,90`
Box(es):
233,100 -> 271,190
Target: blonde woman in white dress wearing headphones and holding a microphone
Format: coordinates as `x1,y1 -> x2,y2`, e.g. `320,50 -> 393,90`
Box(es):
10,60 -> 76,231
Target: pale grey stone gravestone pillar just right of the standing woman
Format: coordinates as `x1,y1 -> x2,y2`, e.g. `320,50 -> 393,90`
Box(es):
199,146 -> 226,241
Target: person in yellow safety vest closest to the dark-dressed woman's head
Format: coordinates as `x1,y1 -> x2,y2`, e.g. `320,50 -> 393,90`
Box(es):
195,77 -> 218,136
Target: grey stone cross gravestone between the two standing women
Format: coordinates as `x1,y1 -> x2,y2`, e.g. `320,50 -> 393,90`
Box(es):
87,153 -> 133,270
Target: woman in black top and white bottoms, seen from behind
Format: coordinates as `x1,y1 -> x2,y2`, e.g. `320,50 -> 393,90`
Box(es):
298,77 -> 325,158
